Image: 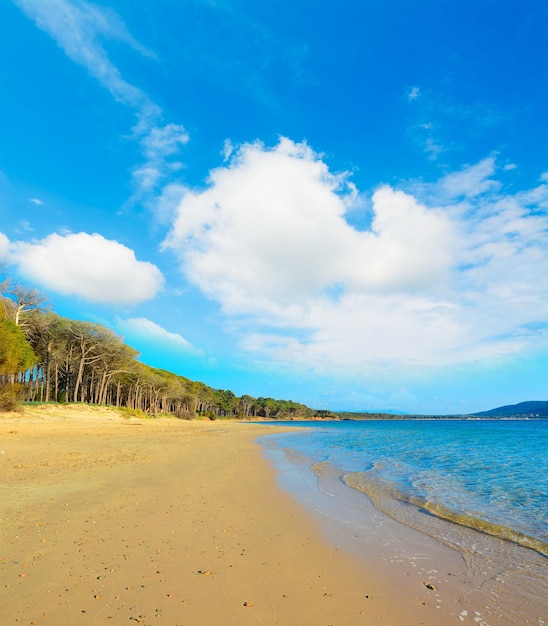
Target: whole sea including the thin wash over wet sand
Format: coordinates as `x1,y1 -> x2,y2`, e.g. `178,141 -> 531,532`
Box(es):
259,419 -> 548,624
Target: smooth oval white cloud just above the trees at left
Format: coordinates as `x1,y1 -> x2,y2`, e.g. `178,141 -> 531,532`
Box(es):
10,233 -> 164,305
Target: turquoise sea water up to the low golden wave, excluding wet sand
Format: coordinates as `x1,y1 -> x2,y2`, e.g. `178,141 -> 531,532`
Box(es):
258,420 -> 548,553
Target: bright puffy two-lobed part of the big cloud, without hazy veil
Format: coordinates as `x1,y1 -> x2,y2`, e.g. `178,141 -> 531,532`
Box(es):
165,139 -> 453,312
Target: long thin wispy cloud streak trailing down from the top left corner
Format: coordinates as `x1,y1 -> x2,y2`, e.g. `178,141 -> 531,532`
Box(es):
13,0 -> 188,210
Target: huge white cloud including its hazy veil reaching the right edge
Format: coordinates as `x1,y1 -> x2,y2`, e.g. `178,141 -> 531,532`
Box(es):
164,139 -> 548,369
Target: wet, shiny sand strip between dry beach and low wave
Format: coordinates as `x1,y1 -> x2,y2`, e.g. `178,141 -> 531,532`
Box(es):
262,422 -> 548,626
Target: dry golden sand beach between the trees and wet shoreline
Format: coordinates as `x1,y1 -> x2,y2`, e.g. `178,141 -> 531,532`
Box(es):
0,407 -> 520,626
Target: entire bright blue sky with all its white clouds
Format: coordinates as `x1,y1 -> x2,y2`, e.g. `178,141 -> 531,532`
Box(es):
0,0 -> 548,414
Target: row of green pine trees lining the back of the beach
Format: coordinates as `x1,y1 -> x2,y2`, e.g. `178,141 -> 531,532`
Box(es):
0,270 -> 322,419
